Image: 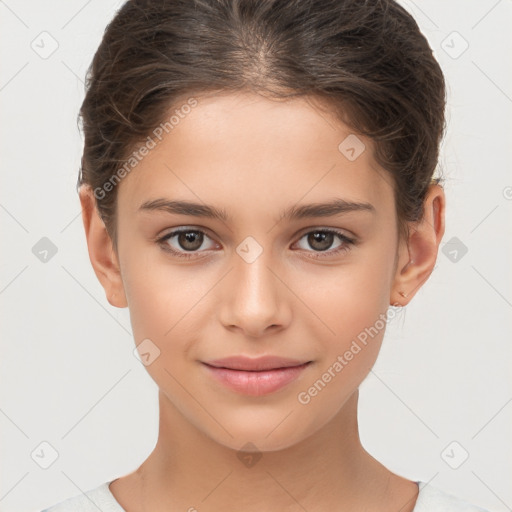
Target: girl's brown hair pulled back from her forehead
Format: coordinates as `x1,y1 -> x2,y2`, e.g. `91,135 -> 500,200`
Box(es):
77,0 -> 446,254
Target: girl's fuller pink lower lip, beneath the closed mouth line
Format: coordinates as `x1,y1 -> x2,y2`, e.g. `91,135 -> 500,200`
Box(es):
204,363 -> 310,396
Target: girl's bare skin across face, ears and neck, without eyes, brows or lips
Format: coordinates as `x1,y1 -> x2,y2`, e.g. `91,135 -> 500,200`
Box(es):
80,92 -> 445,512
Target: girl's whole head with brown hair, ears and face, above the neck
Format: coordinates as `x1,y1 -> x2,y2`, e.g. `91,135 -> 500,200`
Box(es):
79,0 -> 445,450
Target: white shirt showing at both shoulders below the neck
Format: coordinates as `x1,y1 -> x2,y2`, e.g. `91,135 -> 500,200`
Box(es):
41,482 -> 487,512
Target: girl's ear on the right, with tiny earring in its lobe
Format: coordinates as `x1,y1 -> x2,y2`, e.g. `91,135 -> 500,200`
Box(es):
390,184 -> 446,306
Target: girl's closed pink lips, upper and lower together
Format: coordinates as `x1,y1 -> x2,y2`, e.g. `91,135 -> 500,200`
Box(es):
203,356 -> 311,396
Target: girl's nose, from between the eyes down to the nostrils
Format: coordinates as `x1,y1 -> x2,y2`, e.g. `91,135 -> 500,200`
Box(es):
219,251 -> 292,338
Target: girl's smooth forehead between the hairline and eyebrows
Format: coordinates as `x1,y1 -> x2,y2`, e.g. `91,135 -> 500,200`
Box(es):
118,93 -> 393,218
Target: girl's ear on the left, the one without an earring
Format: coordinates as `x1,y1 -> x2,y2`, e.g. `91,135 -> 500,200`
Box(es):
79,185 -> 128,308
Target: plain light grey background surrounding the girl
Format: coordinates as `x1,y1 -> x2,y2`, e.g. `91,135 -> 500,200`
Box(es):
0,0 -> 512,512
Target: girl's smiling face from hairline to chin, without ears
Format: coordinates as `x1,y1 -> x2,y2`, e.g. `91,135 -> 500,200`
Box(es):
117,93 -> 398,450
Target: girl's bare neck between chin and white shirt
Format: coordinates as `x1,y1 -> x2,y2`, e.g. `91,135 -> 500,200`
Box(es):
121,391 -> 417,512
